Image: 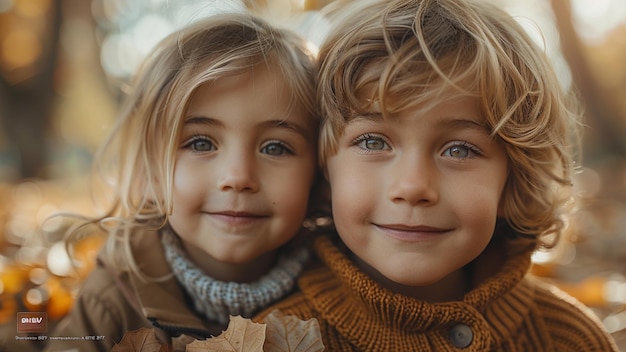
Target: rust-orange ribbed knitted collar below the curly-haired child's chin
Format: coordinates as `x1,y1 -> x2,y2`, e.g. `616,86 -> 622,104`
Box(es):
299,236 -> 532,350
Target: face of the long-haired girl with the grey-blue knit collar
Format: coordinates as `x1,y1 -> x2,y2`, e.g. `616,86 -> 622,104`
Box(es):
169,65 -> 316,267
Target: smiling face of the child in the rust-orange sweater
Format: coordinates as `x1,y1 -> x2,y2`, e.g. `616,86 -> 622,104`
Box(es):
327,97 -> 507,287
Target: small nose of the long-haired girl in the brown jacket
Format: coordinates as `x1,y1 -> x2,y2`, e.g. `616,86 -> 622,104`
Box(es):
213,155 -> 259,193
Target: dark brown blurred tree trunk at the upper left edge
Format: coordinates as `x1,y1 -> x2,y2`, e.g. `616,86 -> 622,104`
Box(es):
0,0 -> 62,178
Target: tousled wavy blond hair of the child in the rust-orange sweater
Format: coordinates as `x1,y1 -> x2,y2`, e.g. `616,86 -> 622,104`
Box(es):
317,0 -> 579,246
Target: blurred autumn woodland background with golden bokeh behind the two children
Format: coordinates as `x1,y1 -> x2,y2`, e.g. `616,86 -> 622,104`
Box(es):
0,0 -> 626,351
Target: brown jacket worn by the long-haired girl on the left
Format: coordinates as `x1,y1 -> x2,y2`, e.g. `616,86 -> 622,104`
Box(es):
45,228 -> 225,352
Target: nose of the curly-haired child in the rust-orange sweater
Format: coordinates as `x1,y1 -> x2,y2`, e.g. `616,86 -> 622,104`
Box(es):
388,156 -> 439,206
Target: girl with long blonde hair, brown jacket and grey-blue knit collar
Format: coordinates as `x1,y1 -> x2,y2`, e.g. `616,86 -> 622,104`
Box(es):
48,14 -> 318,351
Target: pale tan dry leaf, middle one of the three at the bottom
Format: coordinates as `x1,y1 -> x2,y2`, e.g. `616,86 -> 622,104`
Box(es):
186,316 -> 265,352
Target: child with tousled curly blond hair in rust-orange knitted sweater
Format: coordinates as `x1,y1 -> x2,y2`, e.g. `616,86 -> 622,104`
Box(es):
254,0 -> 617,351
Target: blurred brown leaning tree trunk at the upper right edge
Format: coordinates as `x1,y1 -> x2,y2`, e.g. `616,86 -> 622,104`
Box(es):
550,0 -> 626,159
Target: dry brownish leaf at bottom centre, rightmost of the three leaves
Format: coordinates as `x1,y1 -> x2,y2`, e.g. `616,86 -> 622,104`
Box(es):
263,310 -> 324,352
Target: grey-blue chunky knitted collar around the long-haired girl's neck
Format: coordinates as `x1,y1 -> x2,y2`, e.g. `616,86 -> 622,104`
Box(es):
161,228 -> 309,325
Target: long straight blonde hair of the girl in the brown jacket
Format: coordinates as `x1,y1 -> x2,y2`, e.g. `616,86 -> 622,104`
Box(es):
68,13 -> 319,278
